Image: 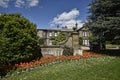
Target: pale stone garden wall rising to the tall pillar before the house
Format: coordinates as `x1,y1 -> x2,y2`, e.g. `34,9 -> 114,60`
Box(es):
41,32 -> 82,56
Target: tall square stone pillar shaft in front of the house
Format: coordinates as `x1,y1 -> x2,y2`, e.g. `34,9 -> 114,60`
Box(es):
72,31 -> 79,49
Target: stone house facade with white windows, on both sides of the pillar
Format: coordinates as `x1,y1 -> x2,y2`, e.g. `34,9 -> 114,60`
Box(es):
37,26 -> 92,46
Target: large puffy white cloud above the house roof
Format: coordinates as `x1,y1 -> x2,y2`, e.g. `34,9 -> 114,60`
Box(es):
50,9 -> 83,28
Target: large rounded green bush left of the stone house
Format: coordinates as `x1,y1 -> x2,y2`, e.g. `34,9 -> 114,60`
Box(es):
0,14 -> 40,76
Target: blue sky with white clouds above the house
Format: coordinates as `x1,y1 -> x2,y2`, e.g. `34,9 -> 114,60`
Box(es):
0,0 -> 92,28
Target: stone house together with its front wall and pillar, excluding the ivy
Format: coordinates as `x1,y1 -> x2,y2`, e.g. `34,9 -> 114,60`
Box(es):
37,26 -> 91,56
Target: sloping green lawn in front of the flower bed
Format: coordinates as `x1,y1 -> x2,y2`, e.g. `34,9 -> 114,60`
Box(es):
1,56 -> 120,80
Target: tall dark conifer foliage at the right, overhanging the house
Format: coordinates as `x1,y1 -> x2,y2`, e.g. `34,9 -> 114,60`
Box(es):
88,0 -> 120,44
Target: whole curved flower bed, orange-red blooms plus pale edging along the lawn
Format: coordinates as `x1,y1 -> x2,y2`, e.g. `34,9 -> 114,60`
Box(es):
0,51 -> 103,77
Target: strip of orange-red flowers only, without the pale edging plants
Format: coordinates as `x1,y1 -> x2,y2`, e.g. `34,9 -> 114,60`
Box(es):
15,51 -> 101,69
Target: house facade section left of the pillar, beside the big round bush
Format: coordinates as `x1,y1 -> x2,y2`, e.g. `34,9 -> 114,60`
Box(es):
37,28 -> 73,46
